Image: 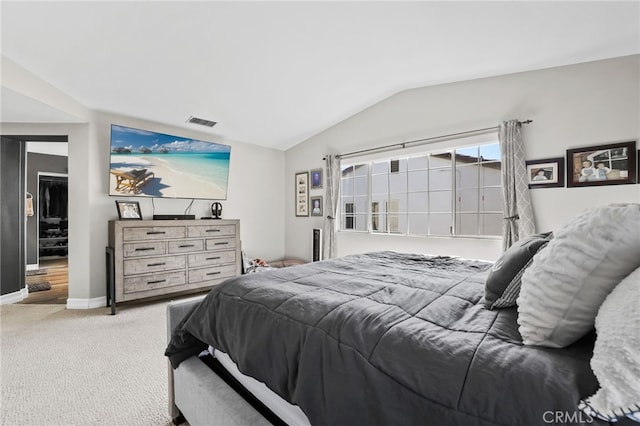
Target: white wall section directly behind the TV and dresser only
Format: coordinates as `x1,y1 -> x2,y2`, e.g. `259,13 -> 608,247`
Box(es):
92,112 -> 284,260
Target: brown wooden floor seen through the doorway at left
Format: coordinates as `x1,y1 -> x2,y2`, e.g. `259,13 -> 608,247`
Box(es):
21,257 -> 69,305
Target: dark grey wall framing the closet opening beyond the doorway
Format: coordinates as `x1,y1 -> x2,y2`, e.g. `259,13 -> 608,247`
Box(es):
27,152 -> 68,265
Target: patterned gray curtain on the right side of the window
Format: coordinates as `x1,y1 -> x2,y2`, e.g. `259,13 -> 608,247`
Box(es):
498,120 -> 535,250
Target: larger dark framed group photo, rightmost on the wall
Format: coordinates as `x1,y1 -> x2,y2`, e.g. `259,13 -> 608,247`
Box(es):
567,141 -> 637,187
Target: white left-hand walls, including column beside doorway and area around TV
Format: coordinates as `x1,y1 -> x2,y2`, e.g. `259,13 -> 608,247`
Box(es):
1,57 -> 285,308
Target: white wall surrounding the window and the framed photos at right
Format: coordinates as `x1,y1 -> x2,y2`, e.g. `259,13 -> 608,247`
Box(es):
285,55 -> 640,260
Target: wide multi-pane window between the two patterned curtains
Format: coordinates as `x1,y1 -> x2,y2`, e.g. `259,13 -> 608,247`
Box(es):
341,143 -> 502,236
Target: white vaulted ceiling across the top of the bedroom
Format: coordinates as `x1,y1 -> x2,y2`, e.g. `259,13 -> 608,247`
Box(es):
0,1 -> 640,149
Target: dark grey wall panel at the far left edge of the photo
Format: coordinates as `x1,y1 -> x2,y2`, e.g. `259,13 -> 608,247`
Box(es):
0,136 -> 26,295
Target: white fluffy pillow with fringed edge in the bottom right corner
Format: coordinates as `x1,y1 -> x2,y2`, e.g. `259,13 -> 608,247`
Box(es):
579,268 -> 640,421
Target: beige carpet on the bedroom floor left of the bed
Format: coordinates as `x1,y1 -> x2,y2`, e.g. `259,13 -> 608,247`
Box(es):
0,301 -> 171,426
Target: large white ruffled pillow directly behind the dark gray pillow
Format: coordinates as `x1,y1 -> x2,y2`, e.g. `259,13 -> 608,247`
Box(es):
517,204 -> 640,348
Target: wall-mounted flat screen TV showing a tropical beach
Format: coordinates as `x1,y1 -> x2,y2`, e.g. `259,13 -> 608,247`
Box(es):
109,124 -> 231,200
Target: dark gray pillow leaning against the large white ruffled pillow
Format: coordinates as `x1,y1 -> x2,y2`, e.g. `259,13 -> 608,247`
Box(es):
484,232 -> 552,309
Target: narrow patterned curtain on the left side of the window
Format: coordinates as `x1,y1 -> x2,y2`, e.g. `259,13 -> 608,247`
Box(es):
322,155 -> 340,259
